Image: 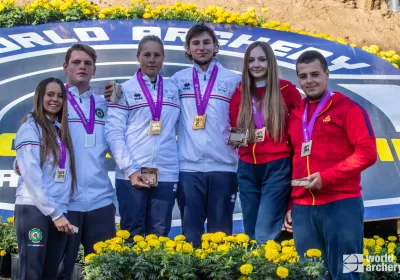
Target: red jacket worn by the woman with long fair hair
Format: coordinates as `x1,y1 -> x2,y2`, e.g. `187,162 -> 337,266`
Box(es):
229,80 -> 301,164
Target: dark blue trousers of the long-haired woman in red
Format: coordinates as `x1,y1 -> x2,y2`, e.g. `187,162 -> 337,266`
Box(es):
238,158 -> 292,244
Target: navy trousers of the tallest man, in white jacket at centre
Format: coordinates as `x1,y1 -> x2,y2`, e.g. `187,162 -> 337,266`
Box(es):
179,172 -> 237,247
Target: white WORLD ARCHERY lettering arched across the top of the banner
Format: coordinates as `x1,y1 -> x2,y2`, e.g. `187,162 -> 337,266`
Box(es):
0,26 -> 376,72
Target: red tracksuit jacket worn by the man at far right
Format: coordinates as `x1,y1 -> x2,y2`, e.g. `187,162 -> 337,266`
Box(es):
288,92 -> 377,209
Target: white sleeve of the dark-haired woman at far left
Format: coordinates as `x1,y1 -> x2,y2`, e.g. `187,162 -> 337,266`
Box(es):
15,124 -> 63,221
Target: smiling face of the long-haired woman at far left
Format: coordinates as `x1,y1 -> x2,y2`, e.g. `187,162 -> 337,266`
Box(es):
43,82 -> 63,121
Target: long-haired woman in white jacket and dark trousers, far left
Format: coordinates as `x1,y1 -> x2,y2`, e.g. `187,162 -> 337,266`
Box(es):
15,78 -> 76,280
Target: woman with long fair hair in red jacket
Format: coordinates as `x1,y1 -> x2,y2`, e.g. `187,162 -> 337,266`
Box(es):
230,42 -> 301,244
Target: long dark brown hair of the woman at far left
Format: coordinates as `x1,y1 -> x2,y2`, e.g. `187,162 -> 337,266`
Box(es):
23,78 -> 76,193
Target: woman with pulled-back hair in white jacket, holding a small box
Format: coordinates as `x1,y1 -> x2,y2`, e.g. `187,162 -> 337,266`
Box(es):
105,35 -> 180,236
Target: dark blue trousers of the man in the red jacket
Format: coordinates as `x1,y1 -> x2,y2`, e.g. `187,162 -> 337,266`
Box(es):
292,198 -> 364,280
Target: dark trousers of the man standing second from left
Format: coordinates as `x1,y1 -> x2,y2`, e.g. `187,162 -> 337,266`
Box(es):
58,204 -> 116,280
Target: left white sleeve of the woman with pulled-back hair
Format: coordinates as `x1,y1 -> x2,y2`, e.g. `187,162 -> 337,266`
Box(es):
105,92 -> 140,177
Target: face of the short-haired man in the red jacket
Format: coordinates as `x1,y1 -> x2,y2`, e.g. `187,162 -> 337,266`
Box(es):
297,60 -> 329,101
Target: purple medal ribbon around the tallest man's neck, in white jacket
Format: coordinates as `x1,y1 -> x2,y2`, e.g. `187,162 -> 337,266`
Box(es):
192,64 -> 218,116
